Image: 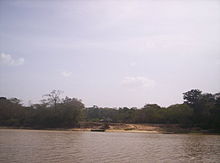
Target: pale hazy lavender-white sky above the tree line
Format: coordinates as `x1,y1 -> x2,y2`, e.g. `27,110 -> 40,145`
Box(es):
0,0 -> 220,107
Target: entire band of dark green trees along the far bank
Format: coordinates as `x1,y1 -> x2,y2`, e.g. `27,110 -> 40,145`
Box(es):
0,89 -> 220,131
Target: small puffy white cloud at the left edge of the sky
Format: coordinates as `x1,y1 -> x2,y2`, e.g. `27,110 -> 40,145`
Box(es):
0,53 -> 24,66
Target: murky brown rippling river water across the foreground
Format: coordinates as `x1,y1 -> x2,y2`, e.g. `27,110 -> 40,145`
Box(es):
0,129 -> 220,163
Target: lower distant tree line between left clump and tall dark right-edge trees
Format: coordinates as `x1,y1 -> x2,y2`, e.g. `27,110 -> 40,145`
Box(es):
84,104 -> 193,124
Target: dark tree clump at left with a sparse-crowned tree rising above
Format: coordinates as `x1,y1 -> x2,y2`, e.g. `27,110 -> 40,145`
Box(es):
0,90 -> 84,128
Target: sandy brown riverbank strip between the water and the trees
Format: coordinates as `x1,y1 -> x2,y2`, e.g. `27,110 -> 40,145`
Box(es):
0,122 -> 220,134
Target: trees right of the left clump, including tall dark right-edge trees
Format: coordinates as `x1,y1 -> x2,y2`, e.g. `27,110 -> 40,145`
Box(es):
82,89 -> 220,130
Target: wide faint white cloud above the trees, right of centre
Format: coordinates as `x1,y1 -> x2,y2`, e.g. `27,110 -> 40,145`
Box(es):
121,76 -> 155,90
